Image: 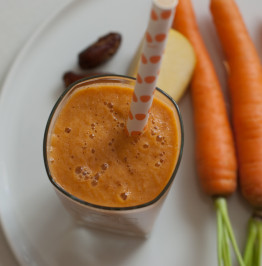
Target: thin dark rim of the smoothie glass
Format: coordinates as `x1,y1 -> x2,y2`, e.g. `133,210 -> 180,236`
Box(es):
43,74 -> 184,211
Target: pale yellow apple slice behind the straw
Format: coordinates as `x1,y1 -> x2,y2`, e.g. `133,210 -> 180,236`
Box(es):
128,29 -> 196,101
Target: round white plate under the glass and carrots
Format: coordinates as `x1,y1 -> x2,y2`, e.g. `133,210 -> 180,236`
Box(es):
0,0 -> 262,266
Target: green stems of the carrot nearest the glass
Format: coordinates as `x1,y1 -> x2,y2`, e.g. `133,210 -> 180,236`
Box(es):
215,197 -> 245,266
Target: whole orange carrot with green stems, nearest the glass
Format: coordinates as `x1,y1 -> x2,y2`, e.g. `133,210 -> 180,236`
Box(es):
173,0 -> 243,265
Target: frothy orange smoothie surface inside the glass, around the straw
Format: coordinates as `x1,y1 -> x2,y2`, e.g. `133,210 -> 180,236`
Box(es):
48,79 -> 181,207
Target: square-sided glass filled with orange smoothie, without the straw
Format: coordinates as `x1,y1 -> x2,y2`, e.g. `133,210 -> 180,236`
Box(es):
44,75 -> 183,236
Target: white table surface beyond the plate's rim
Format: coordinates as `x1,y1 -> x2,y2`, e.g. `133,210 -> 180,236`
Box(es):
0,0 -> 70,266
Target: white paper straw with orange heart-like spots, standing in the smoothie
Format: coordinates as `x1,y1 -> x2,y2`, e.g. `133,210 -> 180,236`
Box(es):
126,0 -> 177,136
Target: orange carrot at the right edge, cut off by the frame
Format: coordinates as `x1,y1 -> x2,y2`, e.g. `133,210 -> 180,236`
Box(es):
210,0 -> 262,266
